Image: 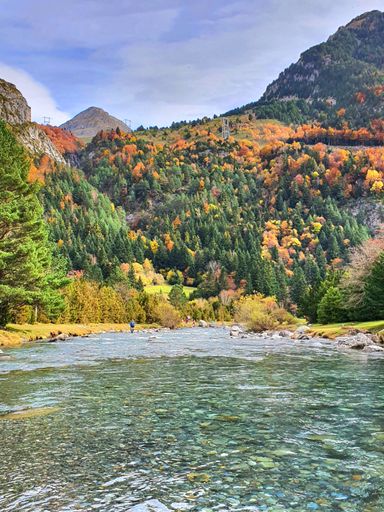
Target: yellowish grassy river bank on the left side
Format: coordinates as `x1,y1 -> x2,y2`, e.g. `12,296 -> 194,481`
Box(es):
0,323 -> 158,347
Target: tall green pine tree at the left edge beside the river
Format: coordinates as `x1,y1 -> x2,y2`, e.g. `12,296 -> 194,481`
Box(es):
0,122 -> 56,326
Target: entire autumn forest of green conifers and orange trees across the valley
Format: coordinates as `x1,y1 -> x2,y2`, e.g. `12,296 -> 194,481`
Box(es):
0,106 -> 384,332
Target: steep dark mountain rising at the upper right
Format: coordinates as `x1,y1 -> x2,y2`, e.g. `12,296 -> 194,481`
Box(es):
231,11 -> 384,126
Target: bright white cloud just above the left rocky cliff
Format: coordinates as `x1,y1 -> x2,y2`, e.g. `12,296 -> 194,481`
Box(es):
0,63 -> 71,126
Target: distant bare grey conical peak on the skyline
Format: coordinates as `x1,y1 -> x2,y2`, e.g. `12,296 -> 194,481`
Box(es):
60,107 -> 130,139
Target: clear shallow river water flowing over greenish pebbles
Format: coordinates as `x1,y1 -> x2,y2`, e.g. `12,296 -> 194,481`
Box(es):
0,329 -> 384,512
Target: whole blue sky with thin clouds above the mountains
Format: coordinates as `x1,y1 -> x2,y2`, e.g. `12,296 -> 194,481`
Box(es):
0,0 -> 384,127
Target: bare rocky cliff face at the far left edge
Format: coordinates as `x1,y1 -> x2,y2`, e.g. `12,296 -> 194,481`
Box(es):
0,78 -> 31,124
